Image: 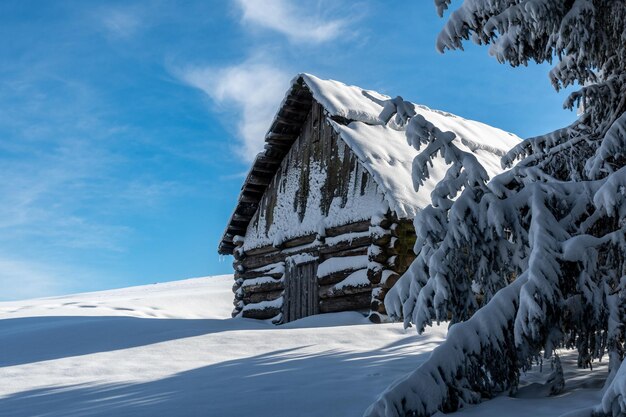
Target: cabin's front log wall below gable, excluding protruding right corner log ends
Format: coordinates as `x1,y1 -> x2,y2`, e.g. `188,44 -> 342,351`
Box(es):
233,221 -> 372,322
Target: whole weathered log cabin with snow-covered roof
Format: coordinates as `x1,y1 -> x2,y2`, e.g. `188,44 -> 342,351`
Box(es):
219,74 -> 519,323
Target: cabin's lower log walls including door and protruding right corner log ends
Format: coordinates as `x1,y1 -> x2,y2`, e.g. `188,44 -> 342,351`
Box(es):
233,211 -> 415,323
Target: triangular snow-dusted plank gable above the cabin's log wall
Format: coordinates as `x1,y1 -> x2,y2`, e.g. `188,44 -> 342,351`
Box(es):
244,102 -> 386,251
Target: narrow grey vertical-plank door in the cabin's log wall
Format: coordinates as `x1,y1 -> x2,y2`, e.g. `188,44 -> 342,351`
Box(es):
283,259 -> 319,323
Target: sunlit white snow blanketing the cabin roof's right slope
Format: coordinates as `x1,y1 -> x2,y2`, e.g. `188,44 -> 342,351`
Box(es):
294,74 -> 521,218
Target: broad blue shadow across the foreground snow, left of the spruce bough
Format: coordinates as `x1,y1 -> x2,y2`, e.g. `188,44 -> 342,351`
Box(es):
0,340 -> 429,417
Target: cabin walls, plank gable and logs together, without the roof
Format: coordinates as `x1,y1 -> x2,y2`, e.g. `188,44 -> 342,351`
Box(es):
233,102 -> 415,322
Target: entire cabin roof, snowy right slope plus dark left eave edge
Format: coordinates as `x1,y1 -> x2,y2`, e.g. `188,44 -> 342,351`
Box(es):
219,74 -> 521,253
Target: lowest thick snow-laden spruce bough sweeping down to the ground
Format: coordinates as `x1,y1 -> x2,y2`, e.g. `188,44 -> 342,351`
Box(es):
365,275 -> 528,417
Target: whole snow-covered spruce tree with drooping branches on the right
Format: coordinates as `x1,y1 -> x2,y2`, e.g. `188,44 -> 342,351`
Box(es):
366,0 -> 626,417
